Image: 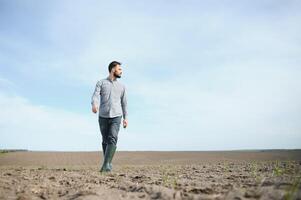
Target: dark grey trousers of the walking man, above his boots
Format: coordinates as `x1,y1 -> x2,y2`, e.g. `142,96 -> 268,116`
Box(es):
98,116 -> 122,145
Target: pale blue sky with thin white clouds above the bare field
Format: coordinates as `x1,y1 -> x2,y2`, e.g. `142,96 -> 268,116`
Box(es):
0,0 -> 301,151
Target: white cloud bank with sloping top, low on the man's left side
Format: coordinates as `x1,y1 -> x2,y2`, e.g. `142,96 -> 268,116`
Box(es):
0,92 -> 101,150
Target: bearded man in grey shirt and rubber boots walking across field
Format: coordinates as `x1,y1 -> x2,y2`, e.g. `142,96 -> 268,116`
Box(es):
91,61 -> 128,172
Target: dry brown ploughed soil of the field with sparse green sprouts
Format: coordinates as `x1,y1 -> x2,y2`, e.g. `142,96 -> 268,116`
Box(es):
0,150 -> 301,199
